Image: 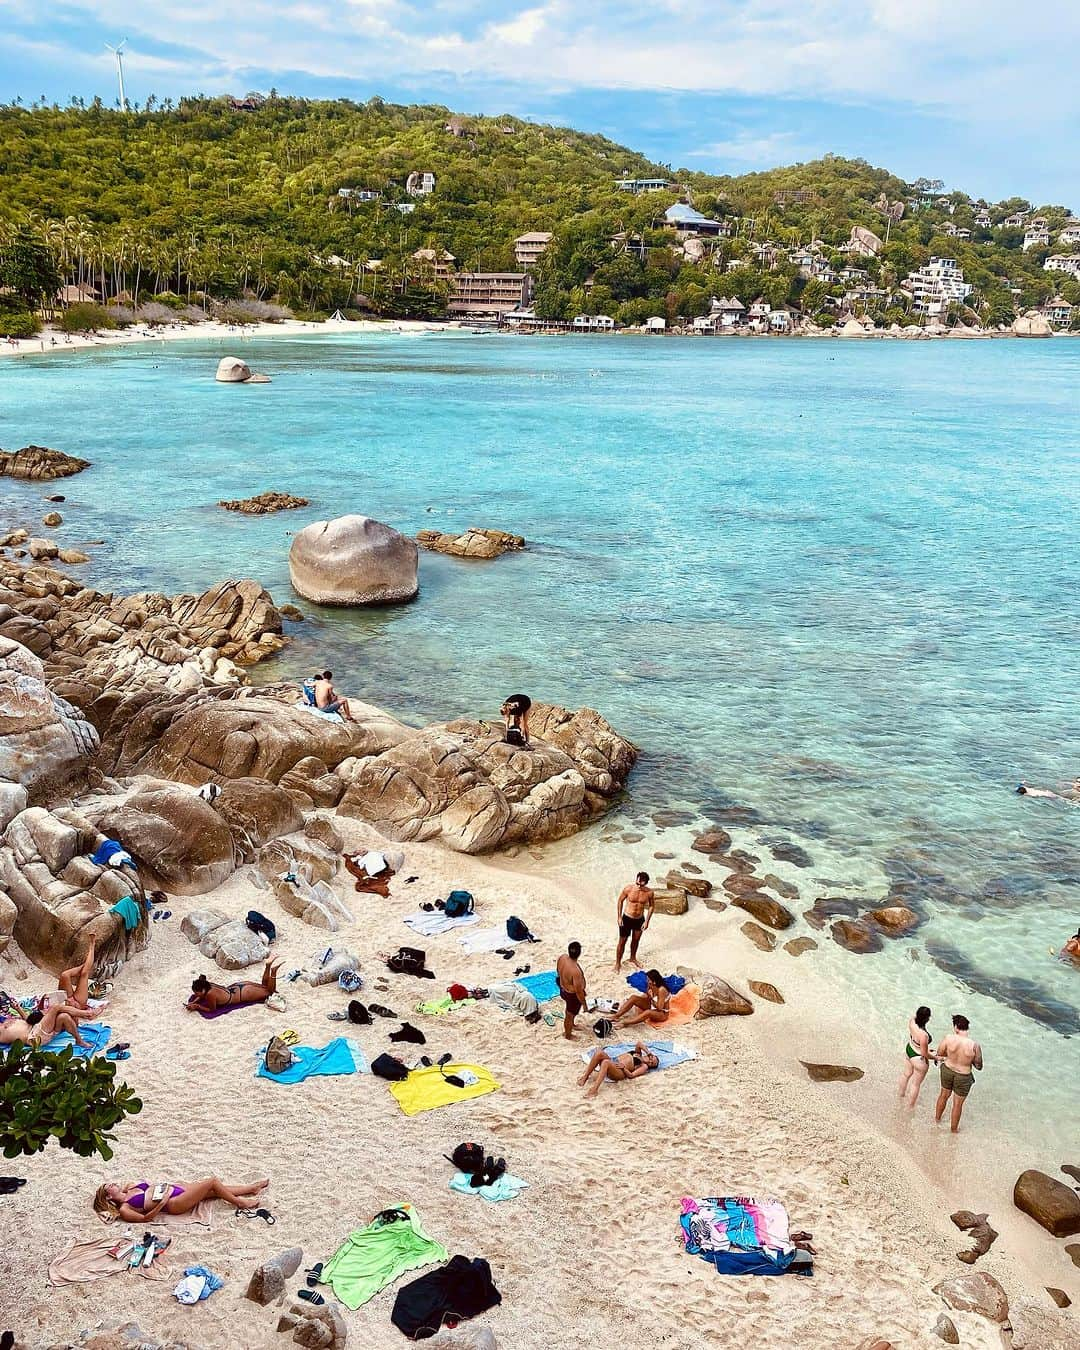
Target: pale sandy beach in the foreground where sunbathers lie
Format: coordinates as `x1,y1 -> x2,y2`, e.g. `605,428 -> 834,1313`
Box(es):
0,799 -> 1080,1350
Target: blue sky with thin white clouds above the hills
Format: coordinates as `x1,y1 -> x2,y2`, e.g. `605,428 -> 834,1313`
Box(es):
0,0 -> 1080,209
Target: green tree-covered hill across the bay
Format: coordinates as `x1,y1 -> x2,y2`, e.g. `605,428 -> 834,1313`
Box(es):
0,96 -> 1073,321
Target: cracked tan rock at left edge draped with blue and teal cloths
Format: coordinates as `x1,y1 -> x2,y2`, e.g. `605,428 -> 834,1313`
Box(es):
0,806 -> 150,973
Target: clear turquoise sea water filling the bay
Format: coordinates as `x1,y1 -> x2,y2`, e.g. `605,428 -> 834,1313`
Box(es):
0,333 -> 1080,1128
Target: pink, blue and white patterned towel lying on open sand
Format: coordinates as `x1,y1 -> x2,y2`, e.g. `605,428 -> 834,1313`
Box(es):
679,1196 -> 809,1274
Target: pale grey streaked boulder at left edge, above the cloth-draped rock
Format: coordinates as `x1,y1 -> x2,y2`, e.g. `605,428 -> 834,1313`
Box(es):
0,636 -> 99,787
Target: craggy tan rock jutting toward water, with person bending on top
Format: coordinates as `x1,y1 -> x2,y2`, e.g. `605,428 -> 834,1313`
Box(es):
338,703 -> 637,853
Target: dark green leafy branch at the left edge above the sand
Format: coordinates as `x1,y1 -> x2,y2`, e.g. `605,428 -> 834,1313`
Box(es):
0,1042 -> 143,1161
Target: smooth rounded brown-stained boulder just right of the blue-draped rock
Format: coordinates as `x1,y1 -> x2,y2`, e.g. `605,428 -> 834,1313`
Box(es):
86,783 -> 236,895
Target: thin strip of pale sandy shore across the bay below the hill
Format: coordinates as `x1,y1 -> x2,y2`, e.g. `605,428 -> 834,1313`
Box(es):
0,319 -> 1080,356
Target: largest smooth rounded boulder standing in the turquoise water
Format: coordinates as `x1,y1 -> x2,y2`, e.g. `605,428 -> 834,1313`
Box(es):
289,516 -> 417,605
